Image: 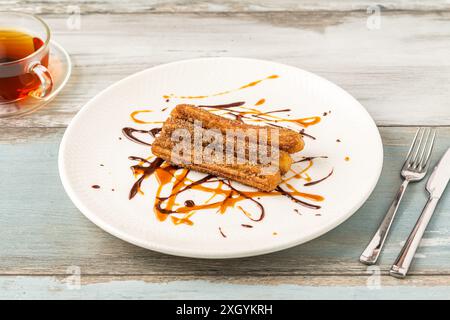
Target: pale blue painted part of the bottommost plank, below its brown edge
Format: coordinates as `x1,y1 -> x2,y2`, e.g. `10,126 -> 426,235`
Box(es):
0,277 -> 450,305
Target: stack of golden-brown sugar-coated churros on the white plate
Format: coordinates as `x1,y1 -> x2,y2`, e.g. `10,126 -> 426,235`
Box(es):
152,105 -> 303,191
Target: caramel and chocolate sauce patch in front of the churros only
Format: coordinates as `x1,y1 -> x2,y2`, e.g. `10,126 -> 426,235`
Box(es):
125,134 -> 326,225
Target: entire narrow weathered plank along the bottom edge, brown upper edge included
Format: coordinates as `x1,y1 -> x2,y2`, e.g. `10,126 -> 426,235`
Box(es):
0,274 -> 450,300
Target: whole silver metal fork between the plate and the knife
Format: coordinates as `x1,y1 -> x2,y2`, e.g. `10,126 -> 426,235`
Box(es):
359,128 -> 436,265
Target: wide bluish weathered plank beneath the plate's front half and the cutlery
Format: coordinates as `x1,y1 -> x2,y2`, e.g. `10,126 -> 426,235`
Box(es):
0,128 -> 450,276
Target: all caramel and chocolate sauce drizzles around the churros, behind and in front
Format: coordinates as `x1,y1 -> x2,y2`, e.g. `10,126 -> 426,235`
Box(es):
122,75 -> 333,228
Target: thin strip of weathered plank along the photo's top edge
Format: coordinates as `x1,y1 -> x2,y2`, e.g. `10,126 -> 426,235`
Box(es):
4,0 -> 450,14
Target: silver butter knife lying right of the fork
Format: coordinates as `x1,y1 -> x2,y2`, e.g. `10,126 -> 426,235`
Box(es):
390,149 -> 450,278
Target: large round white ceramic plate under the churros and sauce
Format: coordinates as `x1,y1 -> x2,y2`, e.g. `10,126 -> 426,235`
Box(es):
59,58 -> 383,258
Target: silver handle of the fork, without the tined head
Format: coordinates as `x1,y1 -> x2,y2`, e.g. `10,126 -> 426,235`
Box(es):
359,179 -> 409,265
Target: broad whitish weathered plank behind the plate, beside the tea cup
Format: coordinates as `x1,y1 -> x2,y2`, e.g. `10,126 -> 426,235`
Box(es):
0,12 -> 450,127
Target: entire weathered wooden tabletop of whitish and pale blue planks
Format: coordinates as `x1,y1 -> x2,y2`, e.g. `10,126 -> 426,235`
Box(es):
0,0 -> 450,299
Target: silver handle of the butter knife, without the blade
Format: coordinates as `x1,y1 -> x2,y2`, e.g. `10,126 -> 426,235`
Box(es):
389,197 -> 439,278
